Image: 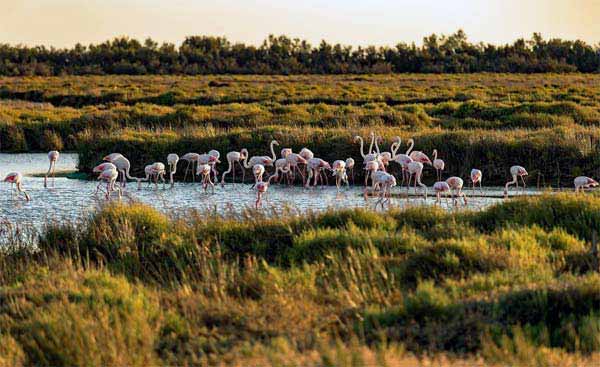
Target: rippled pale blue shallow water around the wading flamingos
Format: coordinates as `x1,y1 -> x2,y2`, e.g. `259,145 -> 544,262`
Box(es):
0,154 -> 536,234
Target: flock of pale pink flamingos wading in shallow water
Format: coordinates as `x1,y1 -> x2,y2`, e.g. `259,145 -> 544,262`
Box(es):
4,133 -> 598,208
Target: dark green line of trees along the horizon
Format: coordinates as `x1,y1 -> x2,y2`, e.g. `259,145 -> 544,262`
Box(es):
0,30 -> 600,76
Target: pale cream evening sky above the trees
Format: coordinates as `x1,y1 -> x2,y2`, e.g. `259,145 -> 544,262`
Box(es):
0,0 -> 600,48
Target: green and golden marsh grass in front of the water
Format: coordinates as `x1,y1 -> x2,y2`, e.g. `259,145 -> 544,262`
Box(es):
0,194 -> 600,366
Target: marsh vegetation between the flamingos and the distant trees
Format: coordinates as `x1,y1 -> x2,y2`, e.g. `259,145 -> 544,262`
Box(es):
0,74 -> 600,186
